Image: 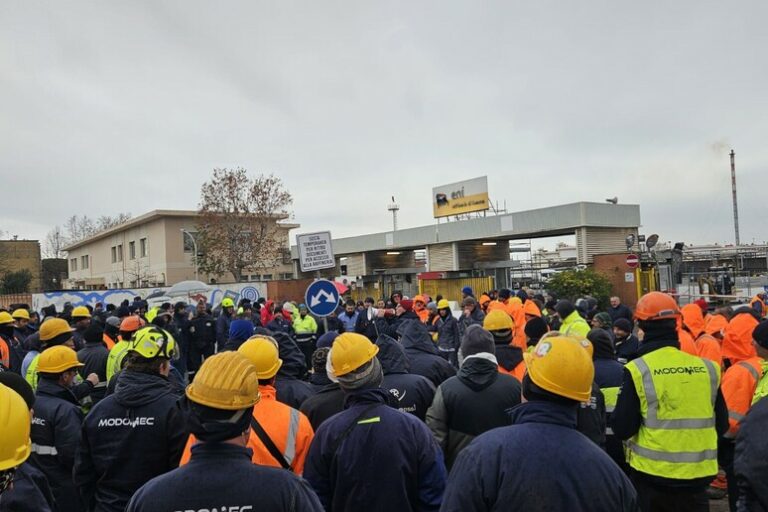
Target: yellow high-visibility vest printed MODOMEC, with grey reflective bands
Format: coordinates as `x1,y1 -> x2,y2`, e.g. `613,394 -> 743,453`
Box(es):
625,347 -> 720,480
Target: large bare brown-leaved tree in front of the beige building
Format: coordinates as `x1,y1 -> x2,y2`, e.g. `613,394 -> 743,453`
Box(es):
196,167 -> 293,281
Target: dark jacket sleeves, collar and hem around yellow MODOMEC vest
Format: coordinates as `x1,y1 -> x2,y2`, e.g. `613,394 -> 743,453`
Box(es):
609,333 -> 728,489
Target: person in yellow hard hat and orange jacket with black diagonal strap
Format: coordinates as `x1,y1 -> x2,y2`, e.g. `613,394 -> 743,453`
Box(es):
179,335 -> 314,475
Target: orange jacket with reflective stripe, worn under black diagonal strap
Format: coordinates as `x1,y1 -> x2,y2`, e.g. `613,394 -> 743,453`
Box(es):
179,386 -> 315,475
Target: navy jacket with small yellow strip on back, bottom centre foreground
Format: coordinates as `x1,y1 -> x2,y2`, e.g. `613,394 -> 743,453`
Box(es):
304,388 -> 445,512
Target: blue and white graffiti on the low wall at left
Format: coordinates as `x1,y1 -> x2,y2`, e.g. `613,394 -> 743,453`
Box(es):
32,283 -> 267,311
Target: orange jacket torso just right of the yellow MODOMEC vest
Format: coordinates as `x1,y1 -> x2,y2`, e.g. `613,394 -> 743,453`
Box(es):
720,357 -> 763,439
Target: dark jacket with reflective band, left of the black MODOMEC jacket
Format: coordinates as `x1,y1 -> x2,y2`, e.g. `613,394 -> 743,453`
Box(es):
30,378 -> 83,512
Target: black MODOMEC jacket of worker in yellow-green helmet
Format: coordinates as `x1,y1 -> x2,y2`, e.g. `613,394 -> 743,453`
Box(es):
74,369 -> 188,512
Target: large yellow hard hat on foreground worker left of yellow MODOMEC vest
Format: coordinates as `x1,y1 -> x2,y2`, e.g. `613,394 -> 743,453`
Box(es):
523,336 -> 595,402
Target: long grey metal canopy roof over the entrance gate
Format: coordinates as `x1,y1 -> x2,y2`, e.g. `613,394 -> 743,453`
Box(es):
291,202 -> 640,259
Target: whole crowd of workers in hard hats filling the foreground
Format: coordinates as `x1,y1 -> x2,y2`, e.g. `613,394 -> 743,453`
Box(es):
0,288 -> 768,512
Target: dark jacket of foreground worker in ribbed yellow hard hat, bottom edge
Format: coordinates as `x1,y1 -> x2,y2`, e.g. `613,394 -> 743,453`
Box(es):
126,443 -> 323,512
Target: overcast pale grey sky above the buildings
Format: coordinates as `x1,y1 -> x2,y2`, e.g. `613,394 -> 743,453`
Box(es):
0,0 -> 768,248
